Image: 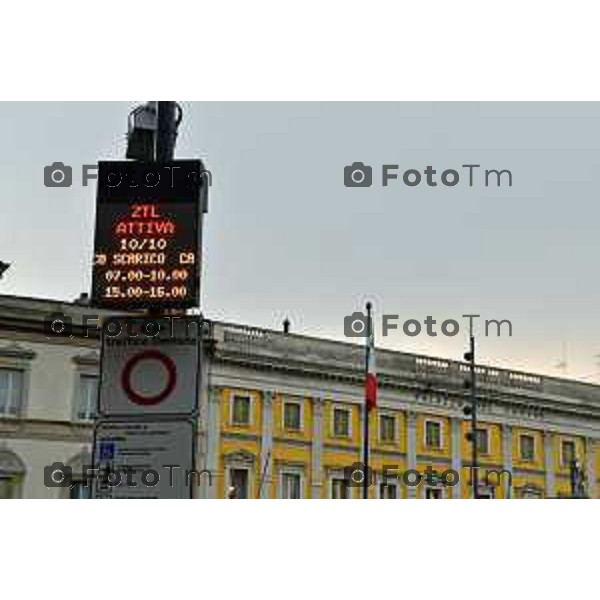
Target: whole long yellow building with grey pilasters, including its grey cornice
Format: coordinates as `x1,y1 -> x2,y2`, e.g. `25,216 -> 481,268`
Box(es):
201,323 -> 600,499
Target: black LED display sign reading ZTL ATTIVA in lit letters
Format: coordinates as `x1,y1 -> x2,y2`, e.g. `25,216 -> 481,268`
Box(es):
92,160 -> 208,310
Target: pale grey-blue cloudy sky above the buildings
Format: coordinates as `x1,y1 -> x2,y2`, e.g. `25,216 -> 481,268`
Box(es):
0,102 -> 600,382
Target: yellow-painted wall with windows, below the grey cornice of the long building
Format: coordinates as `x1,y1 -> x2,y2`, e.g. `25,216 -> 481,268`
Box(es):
205,388 -> 600,499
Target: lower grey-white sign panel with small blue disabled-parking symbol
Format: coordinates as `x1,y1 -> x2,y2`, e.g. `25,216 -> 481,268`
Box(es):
90,419 -> 199,499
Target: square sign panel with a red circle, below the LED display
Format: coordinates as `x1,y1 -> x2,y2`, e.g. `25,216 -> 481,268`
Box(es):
99,317 -> 200,417
